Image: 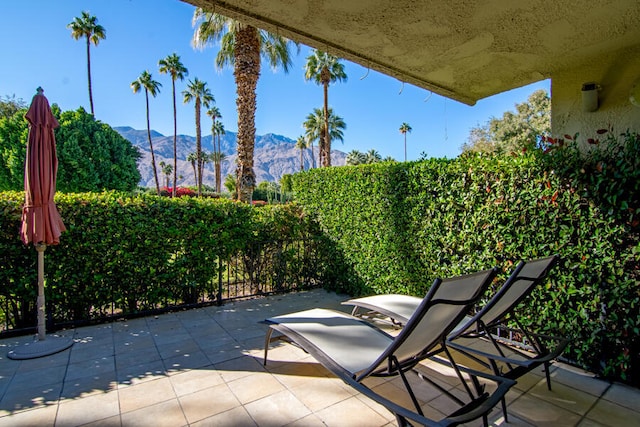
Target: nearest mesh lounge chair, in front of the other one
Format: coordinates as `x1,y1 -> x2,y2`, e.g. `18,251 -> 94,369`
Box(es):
264,269 -> 515,426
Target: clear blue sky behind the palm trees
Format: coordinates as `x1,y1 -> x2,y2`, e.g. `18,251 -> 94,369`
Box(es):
0,0 -> 550,160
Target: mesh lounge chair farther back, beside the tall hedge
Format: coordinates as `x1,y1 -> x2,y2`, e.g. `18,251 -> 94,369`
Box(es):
343,255 -> 568,421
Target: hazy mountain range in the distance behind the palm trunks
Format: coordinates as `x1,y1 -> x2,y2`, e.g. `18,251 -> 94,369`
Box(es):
113,126 -> 347,187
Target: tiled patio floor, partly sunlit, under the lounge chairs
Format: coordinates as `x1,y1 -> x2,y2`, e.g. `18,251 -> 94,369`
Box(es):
0,290 -> 640,427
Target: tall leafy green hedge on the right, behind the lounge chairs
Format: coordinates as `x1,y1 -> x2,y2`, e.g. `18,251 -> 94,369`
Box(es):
293,150 -> 640,383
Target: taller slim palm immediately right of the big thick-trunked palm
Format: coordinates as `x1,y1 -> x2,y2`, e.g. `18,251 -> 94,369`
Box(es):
304,49 -> 347,166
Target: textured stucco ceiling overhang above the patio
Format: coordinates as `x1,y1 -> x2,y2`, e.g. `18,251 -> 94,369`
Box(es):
183,0 -> 640,105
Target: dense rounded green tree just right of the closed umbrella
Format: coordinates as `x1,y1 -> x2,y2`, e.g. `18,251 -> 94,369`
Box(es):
52,106 -> 140,192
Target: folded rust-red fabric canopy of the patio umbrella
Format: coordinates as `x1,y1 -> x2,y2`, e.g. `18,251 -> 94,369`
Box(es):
20,88 -> 66,245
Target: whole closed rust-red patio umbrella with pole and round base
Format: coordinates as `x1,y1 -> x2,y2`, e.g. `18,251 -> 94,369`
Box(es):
8,87 -> 73,359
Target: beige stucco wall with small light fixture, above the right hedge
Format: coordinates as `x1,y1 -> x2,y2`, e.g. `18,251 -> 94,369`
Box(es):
551,46 -> 640,141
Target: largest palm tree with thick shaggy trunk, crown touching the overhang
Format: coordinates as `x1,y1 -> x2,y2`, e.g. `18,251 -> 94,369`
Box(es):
193,8 -> 292,202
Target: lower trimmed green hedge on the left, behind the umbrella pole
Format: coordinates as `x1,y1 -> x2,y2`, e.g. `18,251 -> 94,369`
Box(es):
0,192 -> 335,328
